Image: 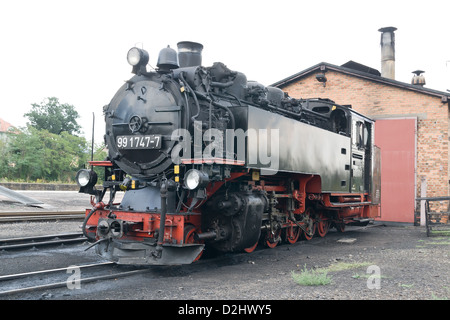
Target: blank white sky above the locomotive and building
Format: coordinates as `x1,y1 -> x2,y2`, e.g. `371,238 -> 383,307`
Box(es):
0,0 -> 450,142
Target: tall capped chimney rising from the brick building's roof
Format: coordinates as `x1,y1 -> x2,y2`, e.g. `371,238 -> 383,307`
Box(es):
378,27 -> 397,80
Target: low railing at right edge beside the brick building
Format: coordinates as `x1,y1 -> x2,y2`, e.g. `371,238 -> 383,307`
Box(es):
416,197 -> 450,237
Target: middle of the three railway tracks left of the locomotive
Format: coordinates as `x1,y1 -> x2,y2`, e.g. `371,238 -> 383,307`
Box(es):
0,232 -> 86,251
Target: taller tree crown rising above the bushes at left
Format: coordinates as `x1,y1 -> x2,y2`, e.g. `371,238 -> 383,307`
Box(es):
24,97 -> 81,135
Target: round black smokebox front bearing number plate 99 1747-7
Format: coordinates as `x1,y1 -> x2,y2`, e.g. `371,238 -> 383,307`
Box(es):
104,74 -> 185,178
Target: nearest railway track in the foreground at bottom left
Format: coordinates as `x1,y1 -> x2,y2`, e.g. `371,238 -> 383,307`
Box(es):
0,262 -> 149,297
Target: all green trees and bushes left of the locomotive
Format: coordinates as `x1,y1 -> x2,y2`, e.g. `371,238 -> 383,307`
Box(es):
0,97 -> 106,182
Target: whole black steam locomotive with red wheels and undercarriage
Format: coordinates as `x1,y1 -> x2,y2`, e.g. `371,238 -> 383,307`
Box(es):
76,41 -> 380,265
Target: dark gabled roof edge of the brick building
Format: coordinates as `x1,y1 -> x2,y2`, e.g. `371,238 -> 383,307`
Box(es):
271,60 -> 450,103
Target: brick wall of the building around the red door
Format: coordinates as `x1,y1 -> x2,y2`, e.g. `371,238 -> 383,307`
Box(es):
281,70 -> 449,197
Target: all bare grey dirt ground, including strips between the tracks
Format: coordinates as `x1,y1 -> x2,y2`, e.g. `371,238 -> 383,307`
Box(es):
0,193 -> 450,303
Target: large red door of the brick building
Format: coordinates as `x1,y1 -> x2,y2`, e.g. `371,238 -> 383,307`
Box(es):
375,119 -> 416,223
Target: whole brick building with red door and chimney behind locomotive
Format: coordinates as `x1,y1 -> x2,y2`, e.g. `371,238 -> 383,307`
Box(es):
272,28 -> 450,222
